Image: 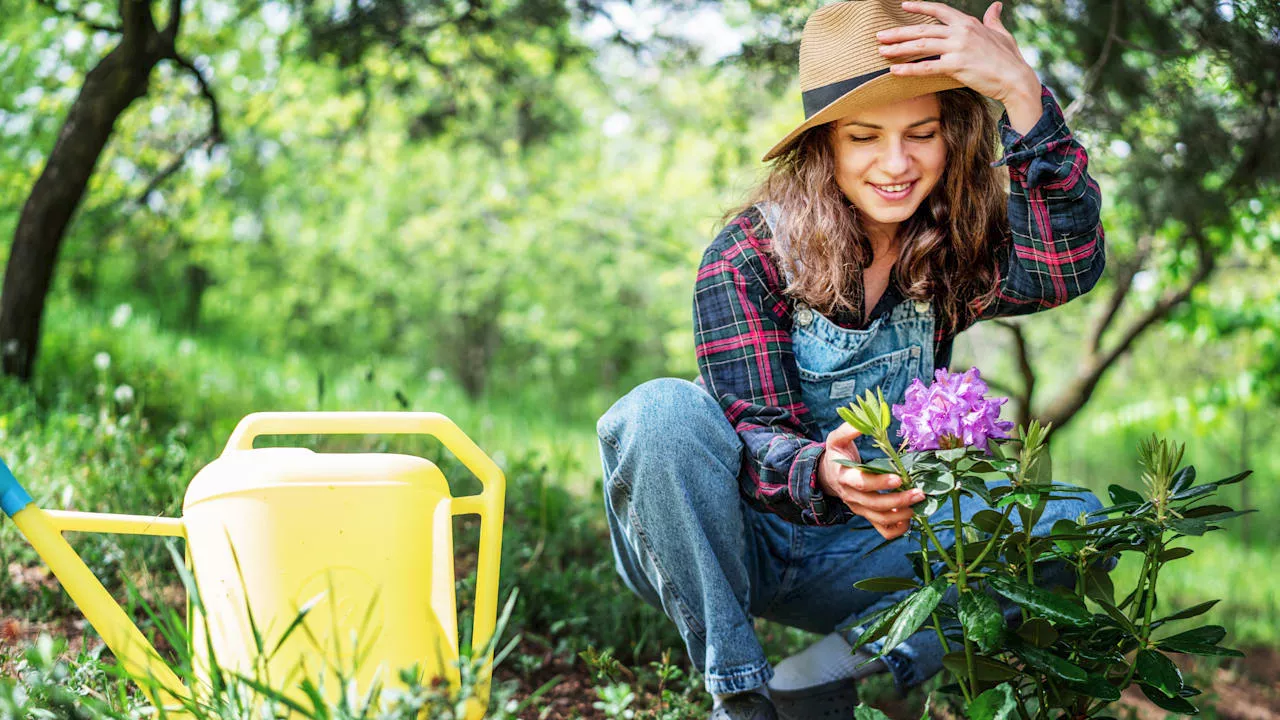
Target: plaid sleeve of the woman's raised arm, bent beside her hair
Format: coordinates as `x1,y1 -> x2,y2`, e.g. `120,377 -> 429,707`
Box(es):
978,86 -> 1106,319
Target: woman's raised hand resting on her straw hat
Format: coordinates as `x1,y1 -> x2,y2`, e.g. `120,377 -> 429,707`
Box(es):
876,1 -> 1041,128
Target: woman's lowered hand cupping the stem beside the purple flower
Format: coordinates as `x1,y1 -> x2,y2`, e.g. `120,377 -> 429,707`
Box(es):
818,423 -> 924,539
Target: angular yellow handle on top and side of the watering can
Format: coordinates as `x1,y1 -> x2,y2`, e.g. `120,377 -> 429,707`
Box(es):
223,413 -> 507,691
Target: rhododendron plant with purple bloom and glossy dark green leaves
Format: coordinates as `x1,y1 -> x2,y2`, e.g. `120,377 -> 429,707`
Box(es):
837,368 -> 1249,720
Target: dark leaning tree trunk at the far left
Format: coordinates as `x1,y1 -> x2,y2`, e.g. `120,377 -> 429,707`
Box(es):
0,11 -> 164,380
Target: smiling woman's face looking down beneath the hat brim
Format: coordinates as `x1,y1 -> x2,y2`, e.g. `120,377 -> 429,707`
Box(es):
832,92 -> 947,236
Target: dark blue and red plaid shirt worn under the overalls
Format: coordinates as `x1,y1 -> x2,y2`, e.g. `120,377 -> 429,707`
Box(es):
694,87 -> 1106,525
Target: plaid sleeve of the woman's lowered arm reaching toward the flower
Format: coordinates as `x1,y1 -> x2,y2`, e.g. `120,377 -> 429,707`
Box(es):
694,214 -> 852,525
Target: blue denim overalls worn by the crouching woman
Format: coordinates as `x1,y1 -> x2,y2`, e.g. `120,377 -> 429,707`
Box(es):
596,206 -> 1100,693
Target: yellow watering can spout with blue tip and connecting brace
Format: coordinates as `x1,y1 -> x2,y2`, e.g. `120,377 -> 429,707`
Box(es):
0,460 -> 189,716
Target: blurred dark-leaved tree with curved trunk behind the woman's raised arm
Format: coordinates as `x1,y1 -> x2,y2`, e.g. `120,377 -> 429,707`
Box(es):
739,0 -> 1280,428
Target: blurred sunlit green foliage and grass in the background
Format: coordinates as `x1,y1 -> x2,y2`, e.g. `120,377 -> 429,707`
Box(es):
0,0 -> 1280,707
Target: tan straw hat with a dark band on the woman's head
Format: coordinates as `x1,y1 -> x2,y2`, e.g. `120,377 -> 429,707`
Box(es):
763,0 -> 963,160
